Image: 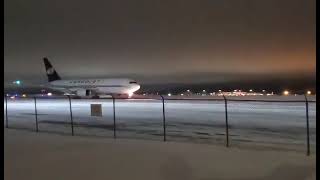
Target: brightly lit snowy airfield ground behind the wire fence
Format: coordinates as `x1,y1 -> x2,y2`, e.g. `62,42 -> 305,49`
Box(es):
4,96 -> 316,151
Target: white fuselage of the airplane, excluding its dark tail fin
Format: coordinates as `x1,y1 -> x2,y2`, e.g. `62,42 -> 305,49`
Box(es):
49,78 -> 140,95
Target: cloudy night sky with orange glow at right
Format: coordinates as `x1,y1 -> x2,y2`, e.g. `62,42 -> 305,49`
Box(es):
4,0 -> 316,89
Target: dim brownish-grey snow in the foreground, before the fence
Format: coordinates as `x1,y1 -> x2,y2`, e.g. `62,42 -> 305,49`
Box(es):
4,129 -> 316,180
